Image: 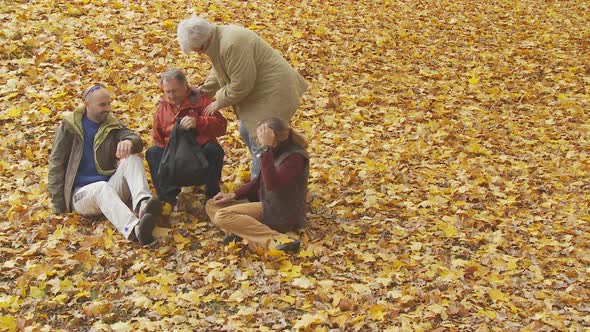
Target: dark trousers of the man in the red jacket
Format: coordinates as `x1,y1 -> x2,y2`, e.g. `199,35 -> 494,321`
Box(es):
145,142 -> 224,204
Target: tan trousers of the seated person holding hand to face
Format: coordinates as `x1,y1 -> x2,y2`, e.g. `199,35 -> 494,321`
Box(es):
205,200 -> 287,248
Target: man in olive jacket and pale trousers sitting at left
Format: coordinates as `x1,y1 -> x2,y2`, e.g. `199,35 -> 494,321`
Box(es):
48,84 -> 162,246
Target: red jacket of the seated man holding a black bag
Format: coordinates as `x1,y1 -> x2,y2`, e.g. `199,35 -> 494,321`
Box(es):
153,88 -> 227,148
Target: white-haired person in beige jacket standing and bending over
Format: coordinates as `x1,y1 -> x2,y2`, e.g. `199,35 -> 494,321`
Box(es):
177,16 -> 308,178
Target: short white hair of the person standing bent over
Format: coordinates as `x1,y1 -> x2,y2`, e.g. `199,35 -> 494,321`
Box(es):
176,15 -> 213,53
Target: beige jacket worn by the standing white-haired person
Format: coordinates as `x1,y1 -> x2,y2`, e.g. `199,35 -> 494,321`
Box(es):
200,25 -> 308,136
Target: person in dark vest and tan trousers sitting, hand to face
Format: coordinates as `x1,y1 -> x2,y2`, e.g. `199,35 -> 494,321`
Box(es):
205,118 -> 309,252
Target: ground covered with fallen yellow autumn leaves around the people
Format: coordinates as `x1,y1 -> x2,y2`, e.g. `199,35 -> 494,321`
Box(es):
0,0 -> 590,331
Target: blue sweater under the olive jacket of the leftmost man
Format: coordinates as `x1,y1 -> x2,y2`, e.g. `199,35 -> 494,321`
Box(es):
74,116 -> 109,188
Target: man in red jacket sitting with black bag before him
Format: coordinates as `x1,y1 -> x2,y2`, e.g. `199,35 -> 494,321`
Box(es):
146,68 -> 227,205
